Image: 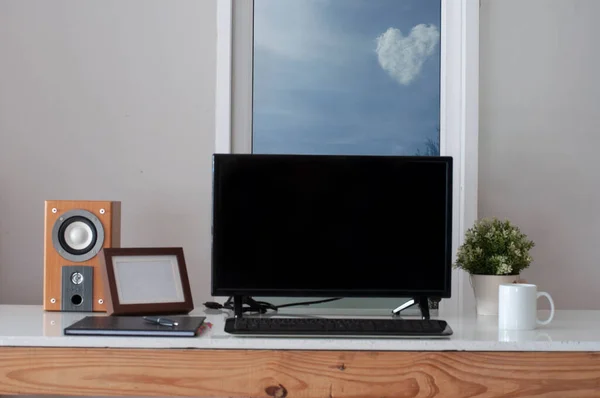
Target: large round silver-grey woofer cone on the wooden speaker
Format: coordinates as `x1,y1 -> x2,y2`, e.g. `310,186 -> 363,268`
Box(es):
52,209 -> 104,262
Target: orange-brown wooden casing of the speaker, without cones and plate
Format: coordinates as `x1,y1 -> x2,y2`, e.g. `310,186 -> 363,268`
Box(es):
44,200 -> 121,311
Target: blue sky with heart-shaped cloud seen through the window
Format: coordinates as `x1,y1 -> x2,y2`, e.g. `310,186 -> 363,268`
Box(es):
253,0 -> 440,155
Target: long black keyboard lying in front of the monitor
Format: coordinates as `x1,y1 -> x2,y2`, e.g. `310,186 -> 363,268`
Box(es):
225,317 -> 452,336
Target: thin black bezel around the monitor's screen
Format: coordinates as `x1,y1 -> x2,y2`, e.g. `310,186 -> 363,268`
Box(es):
211,153 -> 453,298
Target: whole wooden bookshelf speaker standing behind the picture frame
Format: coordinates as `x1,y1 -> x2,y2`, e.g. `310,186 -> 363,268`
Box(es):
44,200 -> 121,312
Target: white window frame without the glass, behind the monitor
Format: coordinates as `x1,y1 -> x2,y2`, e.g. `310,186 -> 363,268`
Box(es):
215,0 -> 479,316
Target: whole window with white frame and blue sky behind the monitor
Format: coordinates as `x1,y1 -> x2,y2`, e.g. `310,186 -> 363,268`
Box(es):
215,0 -> 479,313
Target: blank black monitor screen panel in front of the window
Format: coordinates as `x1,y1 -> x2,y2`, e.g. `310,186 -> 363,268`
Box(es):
212,154 -> 452,297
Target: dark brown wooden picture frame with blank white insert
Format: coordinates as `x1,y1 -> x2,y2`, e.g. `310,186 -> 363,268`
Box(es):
100,247 -> 194,315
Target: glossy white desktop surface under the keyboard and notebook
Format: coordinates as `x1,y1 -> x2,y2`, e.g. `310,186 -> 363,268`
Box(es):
0,305 -> 600,351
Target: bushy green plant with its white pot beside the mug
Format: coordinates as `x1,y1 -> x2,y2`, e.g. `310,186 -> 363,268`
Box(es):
454,218 -> 535,315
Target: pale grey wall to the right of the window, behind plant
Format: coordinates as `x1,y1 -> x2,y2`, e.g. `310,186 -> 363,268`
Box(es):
479,0 -> 600,309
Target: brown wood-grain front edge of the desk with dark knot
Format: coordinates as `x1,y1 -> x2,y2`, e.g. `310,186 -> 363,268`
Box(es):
0,347 -> 600,398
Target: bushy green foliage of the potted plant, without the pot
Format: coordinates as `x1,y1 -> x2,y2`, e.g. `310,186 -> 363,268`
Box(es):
454,218 -> 535,275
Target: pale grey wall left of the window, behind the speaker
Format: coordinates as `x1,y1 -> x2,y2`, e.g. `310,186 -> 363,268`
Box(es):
0,0 -> 216,306
